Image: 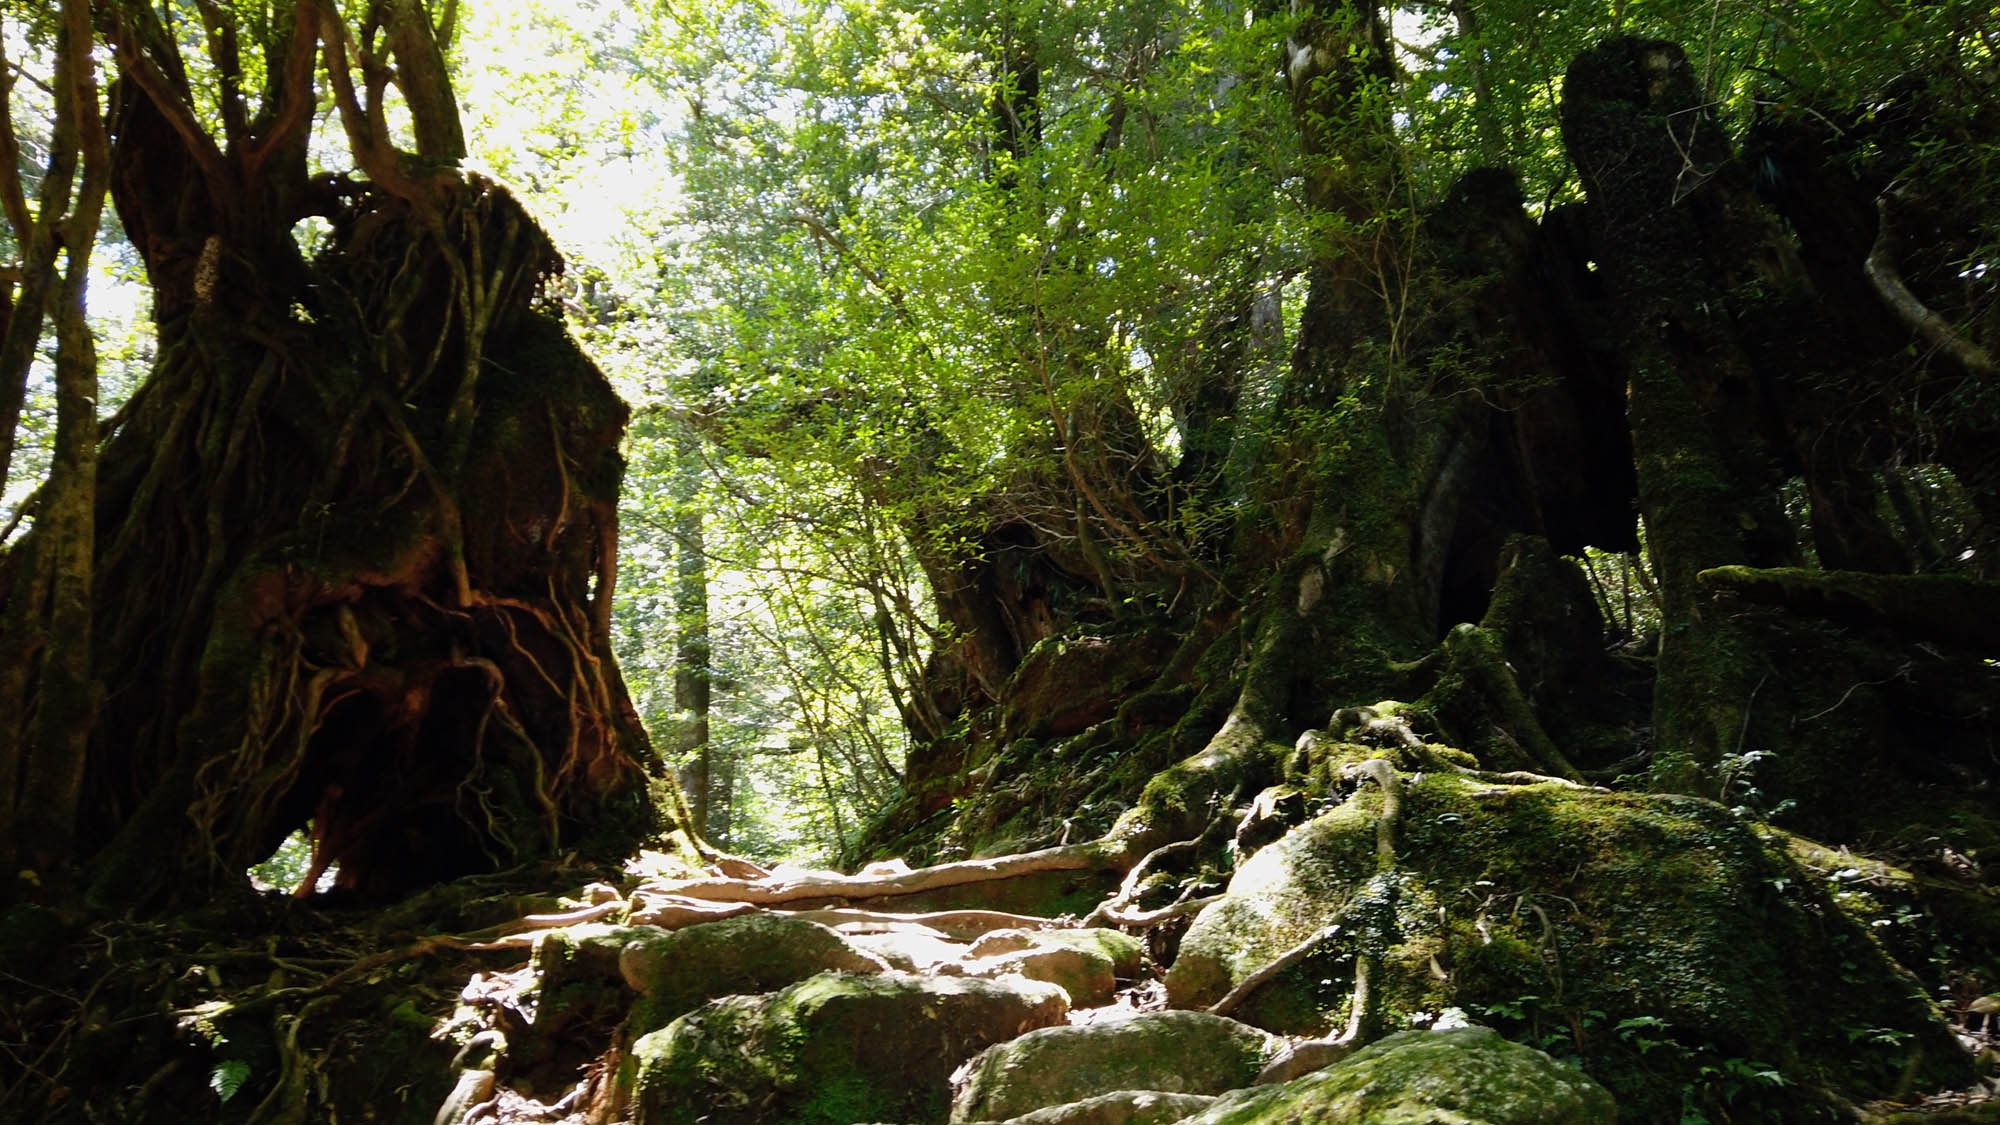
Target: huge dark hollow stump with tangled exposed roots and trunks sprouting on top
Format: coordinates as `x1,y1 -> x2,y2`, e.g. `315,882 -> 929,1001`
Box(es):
6,0 -> 676,905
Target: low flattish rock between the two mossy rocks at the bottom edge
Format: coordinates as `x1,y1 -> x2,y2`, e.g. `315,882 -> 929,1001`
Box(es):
952,1011 -> 1282,1121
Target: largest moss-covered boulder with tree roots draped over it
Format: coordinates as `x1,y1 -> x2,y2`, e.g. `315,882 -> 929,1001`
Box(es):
1166,773 -> 1972,1121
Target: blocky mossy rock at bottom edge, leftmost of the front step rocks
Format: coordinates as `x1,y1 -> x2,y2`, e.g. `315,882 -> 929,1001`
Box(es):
614,973 -> 1070,1125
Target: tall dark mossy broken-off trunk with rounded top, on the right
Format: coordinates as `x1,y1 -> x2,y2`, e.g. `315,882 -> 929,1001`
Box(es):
1562,40 -> 1796,793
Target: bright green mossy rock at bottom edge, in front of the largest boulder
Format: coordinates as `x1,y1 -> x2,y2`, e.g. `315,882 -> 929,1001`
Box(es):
1184,1027 -> 1618,1125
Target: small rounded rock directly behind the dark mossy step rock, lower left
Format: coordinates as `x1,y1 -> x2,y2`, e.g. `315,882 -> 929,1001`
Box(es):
618,911 -> 888,1035
